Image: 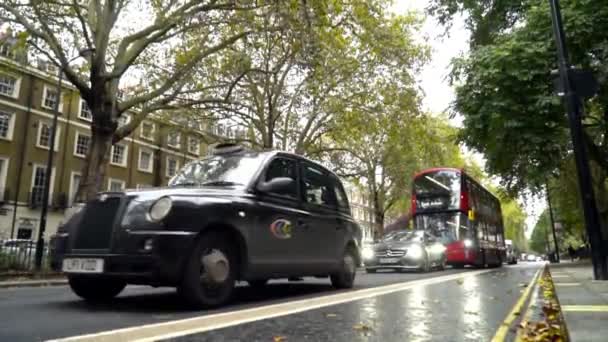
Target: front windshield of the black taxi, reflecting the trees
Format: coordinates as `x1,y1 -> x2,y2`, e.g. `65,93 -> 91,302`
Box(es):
169,153 -> 264,186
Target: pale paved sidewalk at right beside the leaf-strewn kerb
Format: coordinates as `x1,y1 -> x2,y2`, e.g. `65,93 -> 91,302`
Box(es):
549,261 -> 608,342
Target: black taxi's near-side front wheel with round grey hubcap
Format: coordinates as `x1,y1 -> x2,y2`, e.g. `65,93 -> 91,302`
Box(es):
179,232 -> 237,308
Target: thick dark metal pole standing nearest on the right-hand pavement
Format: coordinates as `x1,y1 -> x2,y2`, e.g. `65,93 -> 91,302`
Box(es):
549,0 -> 608,280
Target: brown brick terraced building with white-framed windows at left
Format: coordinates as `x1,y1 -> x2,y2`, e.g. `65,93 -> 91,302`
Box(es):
0,49 -> 226,240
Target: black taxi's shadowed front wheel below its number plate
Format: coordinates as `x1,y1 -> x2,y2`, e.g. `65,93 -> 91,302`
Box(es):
68,276 -> 127,302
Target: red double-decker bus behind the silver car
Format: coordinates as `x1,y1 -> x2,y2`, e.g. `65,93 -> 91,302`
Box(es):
411,168 -> 506,267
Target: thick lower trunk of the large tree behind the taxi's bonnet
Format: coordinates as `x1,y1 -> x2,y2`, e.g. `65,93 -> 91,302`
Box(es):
77,129 -> 113,201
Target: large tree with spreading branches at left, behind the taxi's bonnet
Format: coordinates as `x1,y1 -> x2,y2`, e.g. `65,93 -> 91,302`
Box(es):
0,0 -> 271,197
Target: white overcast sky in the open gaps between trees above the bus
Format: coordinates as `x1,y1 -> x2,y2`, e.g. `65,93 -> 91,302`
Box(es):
393,0 -> 546,237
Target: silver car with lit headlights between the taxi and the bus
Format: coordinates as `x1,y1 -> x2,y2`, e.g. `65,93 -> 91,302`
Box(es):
362,230 -> 446,273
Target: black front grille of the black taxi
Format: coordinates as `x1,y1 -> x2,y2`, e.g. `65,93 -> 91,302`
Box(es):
74,196 -> 122,249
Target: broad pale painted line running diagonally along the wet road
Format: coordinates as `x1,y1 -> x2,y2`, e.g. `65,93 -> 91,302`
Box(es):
47,269 -> 494,342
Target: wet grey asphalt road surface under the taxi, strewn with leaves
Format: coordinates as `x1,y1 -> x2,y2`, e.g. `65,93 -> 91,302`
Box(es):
0,263 -> 541,342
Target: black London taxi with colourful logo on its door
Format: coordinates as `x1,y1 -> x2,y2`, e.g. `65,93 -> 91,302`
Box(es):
51,144 -> 361,308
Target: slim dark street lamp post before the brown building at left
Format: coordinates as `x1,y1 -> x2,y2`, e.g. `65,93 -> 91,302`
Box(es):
35,49 -> 95,271
